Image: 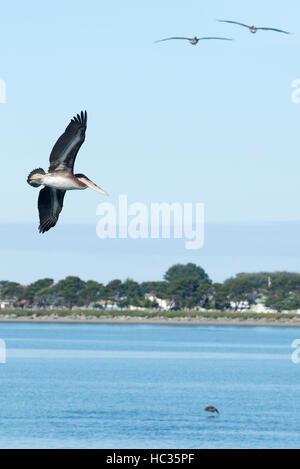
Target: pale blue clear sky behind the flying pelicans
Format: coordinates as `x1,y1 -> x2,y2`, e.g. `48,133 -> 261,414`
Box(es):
0,0 -> 300,282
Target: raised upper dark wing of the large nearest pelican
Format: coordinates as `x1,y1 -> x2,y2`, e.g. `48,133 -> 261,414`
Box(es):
49,111 -> 87,173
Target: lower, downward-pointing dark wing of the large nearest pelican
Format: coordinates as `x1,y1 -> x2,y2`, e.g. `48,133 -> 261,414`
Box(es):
38,186 -> 66,233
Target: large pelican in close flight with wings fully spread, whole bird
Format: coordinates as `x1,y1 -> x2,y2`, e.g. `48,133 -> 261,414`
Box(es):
27,111 -> 108,233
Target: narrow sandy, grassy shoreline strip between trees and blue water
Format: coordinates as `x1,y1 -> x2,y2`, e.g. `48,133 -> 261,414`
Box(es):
0,313 -> 300,327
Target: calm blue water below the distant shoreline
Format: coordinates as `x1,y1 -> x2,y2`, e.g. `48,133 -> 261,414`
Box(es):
0,323 -> 300,449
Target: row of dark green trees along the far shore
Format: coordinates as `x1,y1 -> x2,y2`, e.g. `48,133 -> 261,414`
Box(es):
0,263 -> 300,311
